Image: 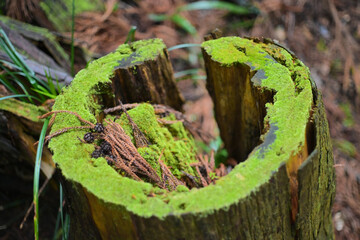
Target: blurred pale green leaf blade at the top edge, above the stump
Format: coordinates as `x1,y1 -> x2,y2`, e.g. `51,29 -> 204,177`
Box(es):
178,1 -> 254,15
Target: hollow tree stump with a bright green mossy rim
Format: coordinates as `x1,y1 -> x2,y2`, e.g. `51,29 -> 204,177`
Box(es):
49,37 -> 335,239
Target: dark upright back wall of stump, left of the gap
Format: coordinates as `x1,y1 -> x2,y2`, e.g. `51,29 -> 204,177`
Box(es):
112,41 -> 184,110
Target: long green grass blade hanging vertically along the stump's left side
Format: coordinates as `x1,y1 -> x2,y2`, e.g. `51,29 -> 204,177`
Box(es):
33,118 -> 49,240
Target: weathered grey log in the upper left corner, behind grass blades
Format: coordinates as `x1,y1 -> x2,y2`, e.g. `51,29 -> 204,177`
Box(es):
0,16 -> 72,85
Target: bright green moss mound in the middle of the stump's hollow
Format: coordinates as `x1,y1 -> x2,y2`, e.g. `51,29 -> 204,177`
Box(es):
117,104 -> 197,178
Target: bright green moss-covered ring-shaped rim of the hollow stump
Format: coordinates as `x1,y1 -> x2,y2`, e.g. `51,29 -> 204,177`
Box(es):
50,37 -> 312,218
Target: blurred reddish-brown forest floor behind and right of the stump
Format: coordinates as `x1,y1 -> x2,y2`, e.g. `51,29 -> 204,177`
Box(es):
0,0 -> 360,240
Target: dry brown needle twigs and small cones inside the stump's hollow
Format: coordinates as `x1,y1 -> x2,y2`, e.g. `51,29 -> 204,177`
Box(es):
40,108 -> 224,190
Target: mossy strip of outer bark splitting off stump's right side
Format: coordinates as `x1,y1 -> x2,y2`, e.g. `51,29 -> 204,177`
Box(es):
295,91 -> 335,239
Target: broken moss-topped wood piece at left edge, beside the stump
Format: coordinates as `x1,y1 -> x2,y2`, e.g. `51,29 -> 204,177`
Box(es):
0,94 -> 55,178
